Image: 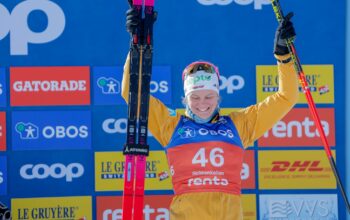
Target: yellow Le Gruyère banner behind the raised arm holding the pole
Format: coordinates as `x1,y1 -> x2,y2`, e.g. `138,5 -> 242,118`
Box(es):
256,65 -> 334,104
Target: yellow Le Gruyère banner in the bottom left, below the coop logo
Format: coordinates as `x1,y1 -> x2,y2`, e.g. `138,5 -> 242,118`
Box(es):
11,196 -> 92,220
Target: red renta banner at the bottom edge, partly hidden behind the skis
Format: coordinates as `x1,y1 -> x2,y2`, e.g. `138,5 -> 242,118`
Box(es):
96,195 -> 173,220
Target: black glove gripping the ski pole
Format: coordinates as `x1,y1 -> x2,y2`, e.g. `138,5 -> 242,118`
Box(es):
273,12 -> 296,55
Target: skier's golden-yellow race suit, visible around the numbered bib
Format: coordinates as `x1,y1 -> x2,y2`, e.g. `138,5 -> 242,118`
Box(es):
122,55 -> 299,220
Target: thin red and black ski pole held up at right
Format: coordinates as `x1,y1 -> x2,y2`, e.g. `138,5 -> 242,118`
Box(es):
271,0 -> 350,213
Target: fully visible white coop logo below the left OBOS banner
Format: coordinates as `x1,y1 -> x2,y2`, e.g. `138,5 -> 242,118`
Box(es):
19,163 -> 84,182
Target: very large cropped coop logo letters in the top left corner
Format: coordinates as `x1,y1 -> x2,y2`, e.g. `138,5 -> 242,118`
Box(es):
0,0 -> 66,55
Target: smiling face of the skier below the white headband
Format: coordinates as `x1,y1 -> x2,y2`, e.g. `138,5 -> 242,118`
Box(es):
186,89 -> 219,119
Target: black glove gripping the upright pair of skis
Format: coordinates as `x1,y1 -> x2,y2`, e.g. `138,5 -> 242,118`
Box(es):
126,7 -> 157,35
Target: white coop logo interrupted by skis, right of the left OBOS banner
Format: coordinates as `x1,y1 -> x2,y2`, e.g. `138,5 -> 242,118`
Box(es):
102,118 -> 152,137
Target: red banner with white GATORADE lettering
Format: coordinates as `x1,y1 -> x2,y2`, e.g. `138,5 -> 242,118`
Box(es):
10,66 -> 90,106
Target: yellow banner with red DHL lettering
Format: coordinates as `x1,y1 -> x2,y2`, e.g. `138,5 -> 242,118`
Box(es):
258,150 -> 336,189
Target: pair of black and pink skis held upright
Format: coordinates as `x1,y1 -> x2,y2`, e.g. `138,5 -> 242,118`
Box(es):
123,0 -> 154,220
